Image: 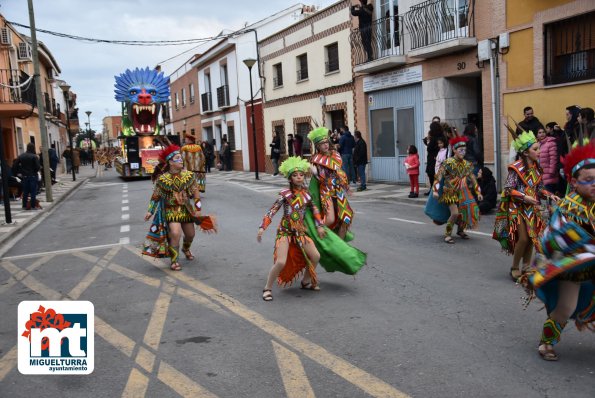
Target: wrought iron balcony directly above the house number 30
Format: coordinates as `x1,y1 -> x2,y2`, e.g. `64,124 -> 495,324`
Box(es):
404,0 -> 477,58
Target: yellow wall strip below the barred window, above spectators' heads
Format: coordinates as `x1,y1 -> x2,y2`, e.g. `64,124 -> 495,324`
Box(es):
502,83 -> 595,136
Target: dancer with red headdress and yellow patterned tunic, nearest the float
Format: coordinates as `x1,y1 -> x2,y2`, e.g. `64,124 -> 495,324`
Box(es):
143,145 -> 215,271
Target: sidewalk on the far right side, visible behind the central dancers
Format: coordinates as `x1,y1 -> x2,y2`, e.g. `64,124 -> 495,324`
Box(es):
212,170 -> 428,206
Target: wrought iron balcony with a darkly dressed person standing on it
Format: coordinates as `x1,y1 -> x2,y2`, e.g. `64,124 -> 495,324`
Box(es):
349,15 -> 406,73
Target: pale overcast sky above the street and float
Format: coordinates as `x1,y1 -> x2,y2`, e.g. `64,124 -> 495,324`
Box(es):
0,0 -> 335,131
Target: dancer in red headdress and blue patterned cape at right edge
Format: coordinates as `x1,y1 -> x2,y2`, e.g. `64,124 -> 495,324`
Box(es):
521,141 -> 595,361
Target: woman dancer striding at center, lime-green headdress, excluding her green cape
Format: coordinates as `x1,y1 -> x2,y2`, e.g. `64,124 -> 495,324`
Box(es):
257,156 -> 326,301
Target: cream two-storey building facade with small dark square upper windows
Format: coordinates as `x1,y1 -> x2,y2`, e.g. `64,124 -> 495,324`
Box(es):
259,1 -> 355,172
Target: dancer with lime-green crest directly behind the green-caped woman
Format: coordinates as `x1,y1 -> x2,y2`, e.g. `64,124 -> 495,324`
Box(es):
308,127 -> 353,240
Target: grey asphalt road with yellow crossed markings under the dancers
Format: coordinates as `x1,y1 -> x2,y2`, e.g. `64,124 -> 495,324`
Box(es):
0,172 -> 595,397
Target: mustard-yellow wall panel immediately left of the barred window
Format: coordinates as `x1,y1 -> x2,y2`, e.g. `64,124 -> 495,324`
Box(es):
503,29 -> 534,88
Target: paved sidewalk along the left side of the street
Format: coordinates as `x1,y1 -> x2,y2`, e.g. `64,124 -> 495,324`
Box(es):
0,166 -> 97,246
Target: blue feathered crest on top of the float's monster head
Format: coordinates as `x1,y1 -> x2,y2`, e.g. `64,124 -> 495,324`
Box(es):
114,66 -> 169,102
